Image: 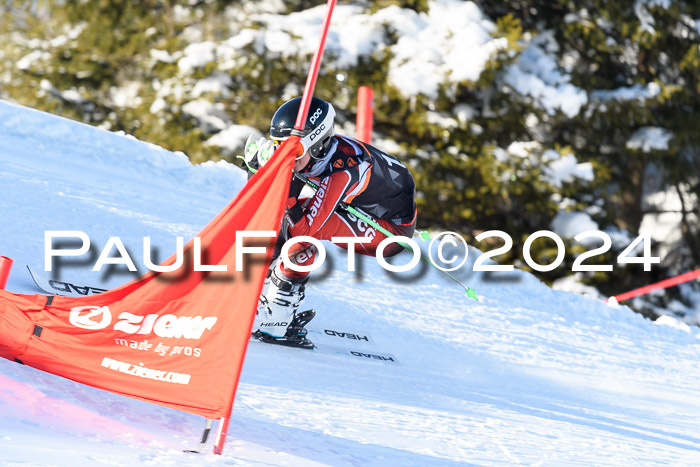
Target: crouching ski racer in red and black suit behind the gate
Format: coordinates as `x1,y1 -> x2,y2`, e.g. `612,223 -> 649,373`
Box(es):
245,97 -> 416,347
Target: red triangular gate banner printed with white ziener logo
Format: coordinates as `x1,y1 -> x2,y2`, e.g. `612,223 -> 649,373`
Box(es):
0,137 -> 299,418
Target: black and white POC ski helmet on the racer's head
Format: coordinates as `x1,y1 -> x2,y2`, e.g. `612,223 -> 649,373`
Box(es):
270,97 -> 335,159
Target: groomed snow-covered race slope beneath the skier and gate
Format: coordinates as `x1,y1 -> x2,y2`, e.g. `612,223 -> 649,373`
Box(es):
0,101 -> 700,466
